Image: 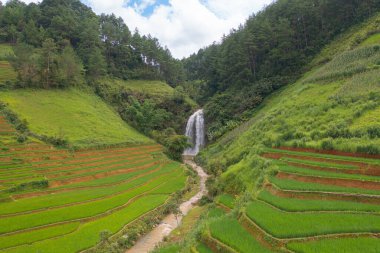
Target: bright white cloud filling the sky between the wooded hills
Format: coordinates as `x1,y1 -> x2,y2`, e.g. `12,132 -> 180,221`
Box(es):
18,0 -> 272,58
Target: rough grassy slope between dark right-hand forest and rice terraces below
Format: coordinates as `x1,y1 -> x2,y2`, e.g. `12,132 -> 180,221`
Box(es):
203,16 -> 380,174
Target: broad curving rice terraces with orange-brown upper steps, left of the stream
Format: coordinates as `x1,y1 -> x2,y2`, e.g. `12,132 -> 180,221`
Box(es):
0,116 -> 187,253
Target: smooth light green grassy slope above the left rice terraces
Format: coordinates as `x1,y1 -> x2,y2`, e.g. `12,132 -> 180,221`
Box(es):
0,89 -> 152,146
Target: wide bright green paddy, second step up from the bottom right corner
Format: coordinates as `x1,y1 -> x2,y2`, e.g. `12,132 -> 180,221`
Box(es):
246,201 -> 380,238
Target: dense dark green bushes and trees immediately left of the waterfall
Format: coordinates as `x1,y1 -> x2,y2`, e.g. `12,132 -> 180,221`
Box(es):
93,79 -> 195,160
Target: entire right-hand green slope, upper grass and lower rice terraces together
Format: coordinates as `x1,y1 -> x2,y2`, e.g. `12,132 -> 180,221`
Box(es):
153,12 -> 380,253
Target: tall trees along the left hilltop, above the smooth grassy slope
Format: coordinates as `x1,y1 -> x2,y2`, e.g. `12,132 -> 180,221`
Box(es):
0,0 -> 184,88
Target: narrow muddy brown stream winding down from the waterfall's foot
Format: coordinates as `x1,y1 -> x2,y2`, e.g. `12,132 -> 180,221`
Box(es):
126,160 -> 208,253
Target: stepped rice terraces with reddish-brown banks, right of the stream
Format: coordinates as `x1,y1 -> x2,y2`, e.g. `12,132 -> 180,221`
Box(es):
198,148 -> 380,253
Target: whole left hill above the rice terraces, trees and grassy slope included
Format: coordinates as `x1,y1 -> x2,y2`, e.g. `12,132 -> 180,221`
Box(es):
0,0 -> 197,159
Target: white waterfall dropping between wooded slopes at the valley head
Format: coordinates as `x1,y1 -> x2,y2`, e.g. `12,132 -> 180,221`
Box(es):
183,110 -> 205,156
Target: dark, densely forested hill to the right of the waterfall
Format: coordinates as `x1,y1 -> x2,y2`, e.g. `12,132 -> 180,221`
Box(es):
184,0 -> 380,140
